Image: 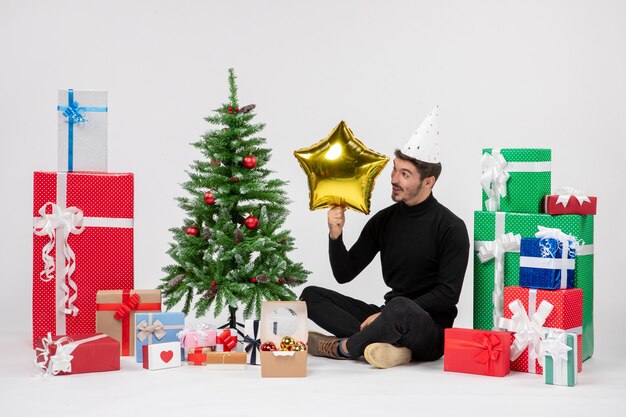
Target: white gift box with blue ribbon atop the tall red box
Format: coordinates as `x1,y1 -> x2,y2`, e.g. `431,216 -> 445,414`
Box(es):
57,89 -> 108,172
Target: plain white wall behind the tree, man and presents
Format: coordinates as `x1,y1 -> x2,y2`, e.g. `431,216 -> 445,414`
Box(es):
0,0 -> 626,355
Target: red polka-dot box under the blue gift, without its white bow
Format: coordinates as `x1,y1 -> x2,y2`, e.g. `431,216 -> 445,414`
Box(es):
501,287 -> 583,375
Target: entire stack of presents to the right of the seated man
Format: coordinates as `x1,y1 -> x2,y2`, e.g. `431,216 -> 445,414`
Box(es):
444,149 -> 597,386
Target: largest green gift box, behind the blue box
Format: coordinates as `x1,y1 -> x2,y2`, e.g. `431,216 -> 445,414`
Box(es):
474,211 -> 594,360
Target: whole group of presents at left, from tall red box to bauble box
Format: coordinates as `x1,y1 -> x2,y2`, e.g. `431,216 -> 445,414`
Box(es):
33,90 -> 308,377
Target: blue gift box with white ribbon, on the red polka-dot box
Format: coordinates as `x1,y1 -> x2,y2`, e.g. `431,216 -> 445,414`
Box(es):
519,238 -> 576,290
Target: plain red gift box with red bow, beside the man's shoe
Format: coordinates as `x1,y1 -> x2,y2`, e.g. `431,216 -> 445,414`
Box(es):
443,328 -> 512,376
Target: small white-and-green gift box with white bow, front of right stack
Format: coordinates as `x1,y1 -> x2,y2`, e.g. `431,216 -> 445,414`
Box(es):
541,332 -> 584,387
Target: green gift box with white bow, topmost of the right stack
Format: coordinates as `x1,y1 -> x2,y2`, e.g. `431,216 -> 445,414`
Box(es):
480,148 -> 552,213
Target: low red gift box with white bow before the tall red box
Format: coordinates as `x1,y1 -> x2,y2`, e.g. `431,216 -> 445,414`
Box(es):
35,333 -> 120,375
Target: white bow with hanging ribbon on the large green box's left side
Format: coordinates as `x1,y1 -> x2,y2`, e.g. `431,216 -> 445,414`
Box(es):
478,232 -> 522,329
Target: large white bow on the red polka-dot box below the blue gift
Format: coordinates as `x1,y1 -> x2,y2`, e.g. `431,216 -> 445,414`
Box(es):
498,300 -> 554,370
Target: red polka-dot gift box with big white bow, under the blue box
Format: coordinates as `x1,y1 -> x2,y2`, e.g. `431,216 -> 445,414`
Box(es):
499,287 -> 583,375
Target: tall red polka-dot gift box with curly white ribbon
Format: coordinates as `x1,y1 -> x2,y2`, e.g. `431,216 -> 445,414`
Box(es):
33,172 -> 134,346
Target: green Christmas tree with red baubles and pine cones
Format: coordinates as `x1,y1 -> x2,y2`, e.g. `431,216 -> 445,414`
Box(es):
159,69 -> 309,327
